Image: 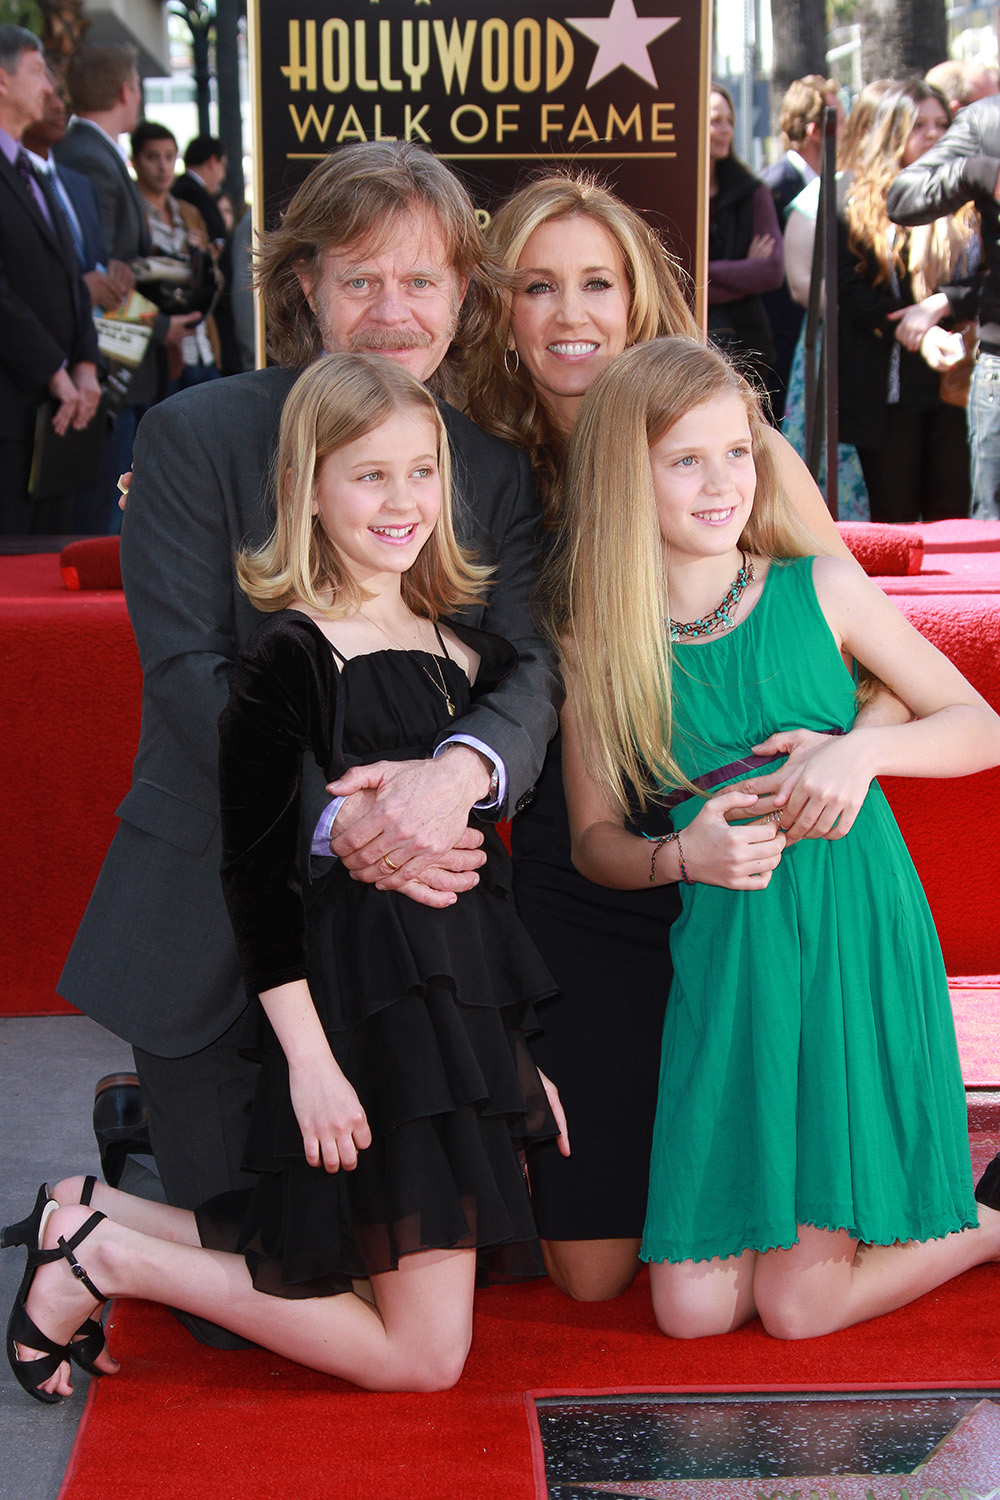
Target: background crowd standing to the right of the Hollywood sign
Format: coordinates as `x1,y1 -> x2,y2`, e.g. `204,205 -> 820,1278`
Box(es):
708,62 -> 1000,522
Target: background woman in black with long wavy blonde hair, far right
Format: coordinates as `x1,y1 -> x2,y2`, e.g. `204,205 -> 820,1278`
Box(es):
838,80 -> 979,522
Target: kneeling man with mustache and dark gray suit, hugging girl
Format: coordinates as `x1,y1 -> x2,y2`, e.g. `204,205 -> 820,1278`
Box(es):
60,143 -> 559,1302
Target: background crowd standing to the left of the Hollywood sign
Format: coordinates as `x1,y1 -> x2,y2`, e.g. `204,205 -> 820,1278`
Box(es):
0,27 -> 253,536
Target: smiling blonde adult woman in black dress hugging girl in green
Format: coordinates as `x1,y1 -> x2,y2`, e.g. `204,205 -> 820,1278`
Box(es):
471,174 -> 905,1301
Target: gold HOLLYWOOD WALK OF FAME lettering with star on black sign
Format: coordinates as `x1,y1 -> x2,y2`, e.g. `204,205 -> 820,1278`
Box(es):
280,0 -> 679,156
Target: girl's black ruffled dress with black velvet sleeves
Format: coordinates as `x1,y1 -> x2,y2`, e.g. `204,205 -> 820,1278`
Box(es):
198,611 -> 556,1298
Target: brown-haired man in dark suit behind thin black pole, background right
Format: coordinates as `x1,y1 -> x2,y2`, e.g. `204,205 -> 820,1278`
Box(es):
760,74 -> 838,423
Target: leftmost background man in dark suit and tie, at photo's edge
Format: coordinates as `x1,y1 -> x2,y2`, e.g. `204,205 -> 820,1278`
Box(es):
0,26 -> 100,536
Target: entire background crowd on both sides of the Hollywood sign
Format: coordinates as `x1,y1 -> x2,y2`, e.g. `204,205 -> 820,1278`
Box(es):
0,29 -> 1000,534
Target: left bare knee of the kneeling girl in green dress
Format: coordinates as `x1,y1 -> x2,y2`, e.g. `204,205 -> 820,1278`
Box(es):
649,1250 -> 757,1338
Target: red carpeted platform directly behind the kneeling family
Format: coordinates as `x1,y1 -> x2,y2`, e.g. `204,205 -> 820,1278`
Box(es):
0,521 -> 1000,1016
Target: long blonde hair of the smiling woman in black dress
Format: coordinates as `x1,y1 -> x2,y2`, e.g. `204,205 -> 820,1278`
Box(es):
468,173 -> 697,528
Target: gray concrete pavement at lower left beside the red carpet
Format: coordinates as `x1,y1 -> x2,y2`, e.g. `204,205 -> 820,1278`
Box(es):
0,1016 -> 132,1500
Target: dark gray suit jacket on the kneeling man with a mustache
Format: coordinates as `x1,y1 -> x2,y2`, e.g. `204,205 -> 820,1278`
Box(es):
60,369 -> 561,1058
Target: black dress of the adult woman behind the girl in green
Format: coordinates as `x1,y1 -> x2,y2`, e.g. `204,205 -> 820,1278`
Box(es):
511,737 -> 681,1239
